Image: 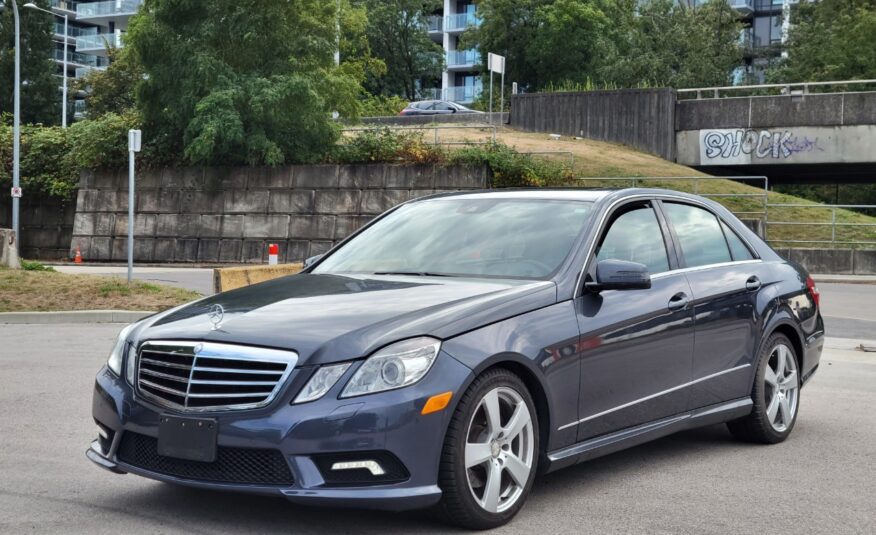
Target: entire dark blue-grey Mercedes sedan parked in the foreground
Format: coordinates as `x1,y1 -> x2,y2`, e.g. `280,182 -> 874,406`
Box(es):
87,189 -> 824,529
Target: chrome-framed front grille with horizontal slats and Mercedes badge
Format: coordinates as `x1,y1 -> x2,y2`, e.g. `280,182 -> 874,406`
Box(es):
137,341 -> 298,412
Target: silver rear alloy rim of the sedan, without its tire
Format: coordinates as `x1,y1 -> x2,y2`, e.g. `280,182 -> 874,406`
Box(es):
764,344 -> 800,433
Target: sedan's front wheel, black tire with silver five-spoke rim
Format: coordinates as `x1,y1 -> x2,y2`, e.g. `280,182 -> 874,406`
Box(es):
435,368 -> 539,529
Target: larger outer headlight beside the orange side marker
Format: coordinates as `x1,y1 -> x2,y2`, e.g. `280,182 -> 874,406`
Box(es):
341,337 -> 441,398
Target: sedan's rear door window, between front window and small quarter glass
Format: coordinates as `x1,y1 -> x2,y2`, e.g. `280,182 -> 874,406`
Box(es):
663,203 -> 732,267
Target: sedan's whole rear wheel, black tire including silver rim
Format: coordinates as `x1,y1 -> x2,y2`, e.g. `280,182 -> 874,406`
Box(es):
727,333 -> 800,444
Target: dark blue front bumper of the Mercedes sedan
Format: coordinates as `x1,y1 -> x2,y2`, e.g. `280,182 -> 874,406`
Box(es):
86,353 -> 471,510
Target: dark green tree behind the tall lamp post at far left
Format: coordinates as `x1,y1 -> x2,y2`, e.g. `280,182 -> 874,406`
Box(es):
0,0 -> 61,124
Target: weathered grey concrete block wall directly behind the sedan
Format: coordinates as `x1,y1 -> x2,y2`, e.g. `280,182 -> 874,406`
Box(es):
69,164 -> 489,264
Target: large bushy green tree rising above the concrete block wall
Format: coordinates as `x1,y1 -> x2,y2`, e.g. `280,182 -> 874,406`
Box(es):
125,0 -> 360,165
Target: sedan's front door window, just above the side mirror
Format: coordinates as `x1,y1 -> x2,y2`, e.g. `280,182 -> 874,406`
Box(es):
596,206 -> 669,274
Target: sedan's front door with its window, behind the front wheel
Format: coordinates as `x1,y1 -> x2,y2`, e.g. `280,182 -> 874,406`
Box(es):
575,201 -> 694,441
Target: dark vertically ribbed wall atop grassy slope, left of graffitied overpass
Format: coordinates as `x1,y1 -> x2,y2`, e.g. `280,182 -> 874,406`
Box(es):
510,89 -> 675,160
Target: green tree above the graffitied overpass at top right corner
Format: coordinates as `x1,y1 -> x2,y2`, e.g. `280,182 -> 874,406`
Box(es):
767,0 -> 876,83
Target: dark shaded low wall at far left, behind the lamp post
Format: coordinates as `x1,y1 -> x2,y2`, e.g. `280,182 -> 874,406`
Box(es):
0,192 -> 76,260
